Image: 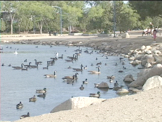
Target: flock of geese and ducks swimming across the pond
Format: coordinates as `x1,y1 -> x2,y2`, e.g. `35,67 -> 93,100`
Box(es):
1,43 -> 129,119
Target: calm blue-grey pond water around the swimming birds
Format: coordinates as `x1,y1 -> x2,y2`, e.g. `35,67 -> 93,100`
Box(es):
0,44 -> 138,121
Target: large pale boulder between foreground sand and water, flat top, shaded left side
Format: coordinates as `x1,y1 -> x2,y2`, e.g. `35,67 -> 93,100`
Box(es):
50,97 -> 105,113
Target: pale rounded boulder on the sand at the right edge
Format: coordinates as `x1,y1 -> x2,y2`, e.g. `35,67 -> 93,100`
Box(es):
142,76 -> 162,91
